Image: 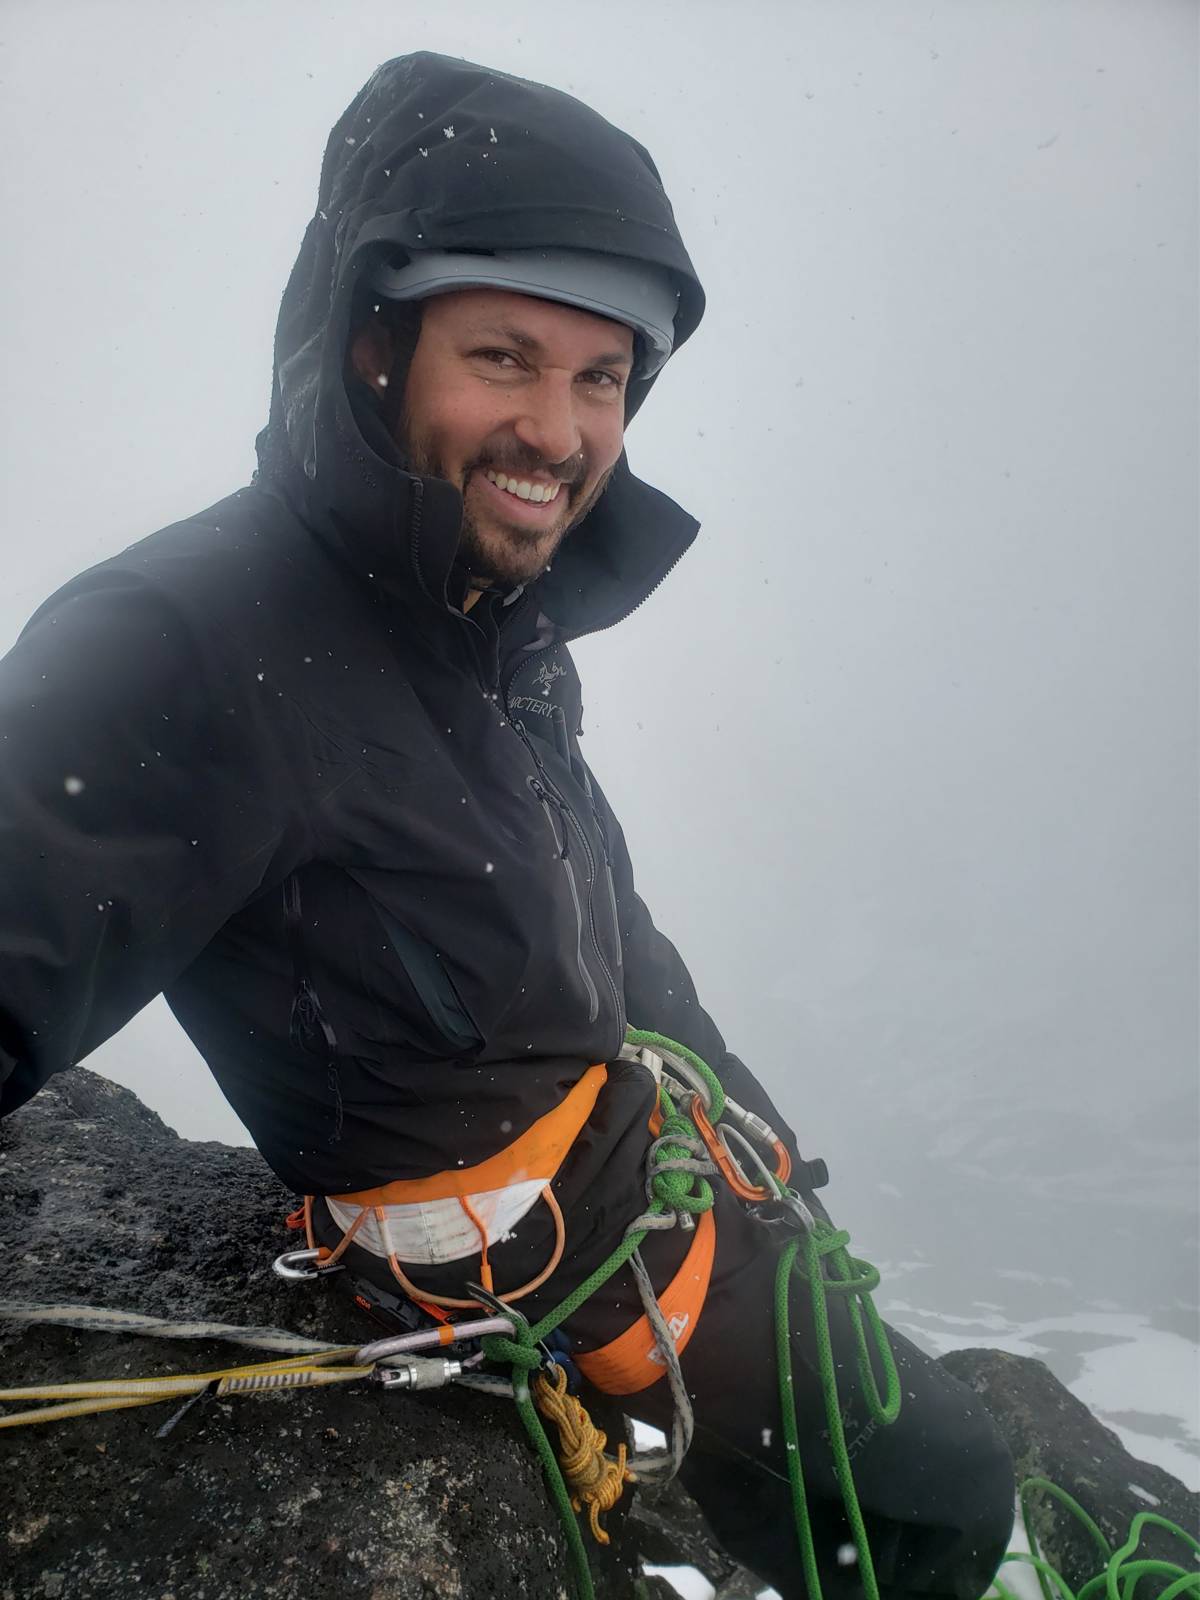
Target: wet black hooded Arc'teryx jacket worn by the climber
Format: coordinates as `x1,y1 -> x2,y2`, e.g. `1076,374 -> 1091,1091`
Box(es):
0,54 -> 800,1218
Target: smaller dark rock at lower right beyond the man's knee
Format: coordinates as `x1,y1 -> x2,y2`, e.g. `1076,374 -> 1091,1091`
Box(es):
941,1350 -> 1200,1595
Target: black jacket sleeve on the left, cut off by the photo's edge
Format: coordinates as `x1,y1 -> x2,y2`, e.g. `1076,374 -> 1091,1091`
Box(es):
0,563 -> 310,1115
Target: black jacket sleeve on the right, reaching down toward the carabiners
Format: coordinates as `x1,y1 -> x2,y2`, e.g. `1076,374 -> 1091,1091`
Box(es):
589,774 -> 798,1158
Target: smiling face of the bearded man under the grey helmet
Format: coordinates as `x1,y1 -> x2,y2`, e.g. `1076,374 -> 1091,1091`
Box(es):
350,290 -> 634,587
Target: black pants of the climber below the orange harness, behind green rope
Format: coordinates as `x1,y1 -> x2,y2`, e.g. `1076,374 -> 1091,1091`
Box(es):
568,1184 -> 1014,1600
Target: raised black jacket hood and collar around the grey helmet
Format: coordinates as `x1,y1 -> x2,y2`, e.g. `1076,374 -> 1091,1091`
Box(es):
258,51 -> 704,635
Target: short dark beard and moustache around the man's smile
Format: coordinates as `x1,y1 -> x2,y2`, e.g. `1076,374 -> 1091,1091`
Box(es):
397,413 -> 616,589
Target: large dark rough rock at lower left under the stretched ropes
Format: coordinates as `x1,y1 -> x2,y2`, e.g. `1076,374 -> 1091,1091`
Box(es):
0,1069 -> 634,1600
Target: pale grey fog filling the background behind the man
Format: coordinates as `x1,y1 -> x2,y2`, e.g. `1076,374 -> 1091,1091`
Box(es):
0,0 -> 1200,1477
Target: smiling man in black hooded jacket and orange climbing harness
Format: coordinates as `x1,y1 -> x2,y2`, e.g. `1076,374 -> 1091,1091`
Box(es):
0,54 -> 1013,1597
